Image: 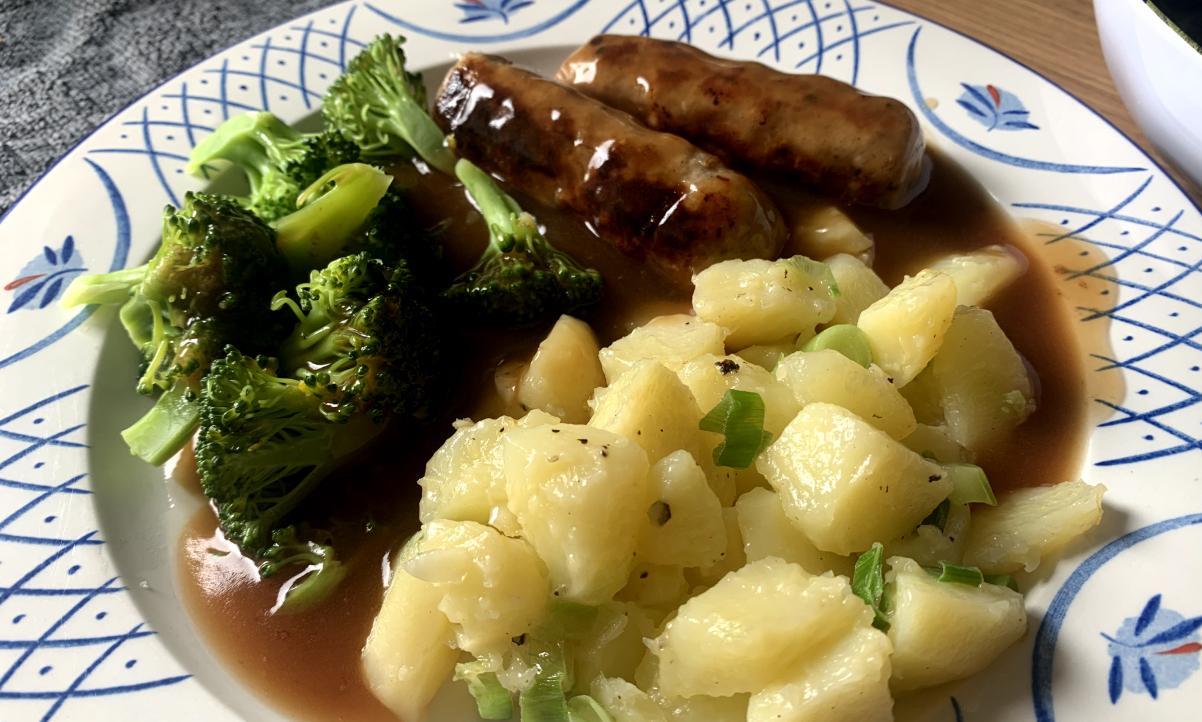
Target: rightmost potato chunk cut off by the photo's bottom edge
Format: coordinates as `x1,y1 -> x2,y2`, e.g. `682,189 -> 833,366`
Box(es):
748,623 -> 893,722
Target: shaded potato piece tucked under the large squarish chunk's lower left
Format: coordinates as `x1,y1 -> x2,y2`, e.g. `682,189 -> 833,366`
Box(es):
734,489 -> 852,577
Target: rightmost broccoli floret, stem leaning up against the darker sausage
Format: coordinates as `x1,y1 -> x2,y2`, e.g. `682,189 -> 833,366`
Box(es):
442,160 -> 601,326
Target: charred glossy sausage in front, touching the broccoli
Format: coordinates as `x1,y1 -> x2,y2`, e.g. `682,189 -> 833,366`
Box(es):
434,53 -> 787,286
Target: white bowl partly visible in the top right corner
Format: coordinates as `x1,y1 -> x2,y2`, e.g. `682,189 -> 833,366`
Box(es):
1094,0 -> 1202,185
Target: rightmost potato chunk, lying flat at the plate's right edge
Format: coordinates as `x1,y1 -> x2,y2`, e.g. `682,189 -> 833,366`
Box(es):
964,482 -> 1106,574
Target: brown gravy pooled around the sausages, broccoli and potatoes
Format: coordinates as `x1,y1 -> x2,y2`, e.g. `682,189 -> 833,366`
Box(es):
180,148 -> 1088,722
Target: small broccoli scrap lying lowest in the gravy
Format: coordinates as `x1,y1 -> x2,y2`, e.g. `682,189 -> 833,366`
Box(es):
258,526 -> 346,614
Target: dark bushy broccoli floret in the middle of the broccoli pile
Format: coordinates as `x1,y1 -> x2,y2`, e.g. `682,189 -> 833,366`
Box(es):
272,252 -> 442,420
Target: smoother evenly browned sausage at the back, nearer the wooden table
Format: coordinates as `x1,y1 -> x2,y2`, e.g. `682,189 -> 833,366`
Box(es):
559,35 -> 930,208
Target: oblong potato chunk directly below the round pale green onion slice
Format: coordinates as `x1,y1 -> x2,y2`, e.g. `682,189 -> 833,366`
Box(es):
776,348 -> 915,438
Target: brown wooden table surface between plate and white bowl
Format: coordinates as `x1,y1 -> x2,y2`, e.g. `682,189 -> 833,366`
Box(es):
887,0 -> 1202,203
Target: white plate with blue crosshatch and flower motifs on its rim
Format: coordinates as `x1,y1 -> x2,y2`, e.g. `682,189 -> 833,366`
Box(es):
0,0 -> 1202,722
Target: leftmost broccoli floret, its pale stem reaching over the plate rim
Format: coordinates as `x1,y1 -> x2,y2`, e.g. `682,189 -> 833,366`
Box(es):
63,193 -> 288,465
